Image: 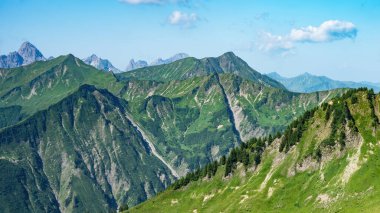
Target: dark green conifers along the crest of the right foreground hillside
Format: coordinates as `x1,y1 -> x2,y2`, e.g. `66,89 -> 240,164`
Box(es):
171,88 -> 379,190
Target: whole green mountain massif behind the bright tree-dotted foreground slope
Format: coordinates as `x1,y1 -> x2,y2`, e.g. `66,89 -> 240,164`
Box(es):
0,48 -> 343,212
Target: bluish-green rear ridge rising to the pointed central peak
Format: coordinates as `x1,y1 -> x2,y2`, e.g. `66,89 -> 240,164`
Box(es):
120,52 -> 285,89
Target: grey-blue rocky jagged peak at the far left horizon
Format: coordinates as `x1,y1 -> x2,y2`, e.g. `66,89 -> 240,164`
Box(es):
0,42 -> 46,68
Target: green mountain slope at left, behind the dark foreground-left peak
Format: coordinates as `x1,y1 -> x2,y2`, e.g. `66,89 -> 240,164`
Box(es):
0,55 -> 121,126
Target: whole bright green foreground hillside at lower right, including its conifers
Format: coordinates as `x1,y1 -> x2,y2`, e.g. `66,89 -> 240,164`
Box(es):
130,89 -> 380,212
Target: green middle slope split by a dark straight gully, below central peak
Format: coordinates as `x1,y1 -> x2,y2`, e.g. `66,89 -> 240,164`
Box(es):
121,74 -> 343,174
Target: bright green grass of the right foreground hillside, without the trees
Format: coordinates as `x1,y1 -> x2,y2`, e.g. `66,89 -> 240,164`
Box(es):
130,91 -> 380,212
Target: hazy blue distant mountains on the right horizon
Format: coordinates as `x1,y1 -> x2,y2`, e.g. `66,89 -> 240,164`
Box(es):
267,72 -> 380,93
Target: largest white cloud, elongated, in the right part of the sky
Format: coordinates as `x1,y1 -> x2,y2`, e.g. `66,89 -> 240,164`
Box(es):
259,20 -> 358,53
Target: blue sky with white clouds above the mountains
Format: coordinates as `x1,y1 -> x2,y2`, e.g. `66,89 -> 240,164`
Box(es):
0,0 -> 380,82
